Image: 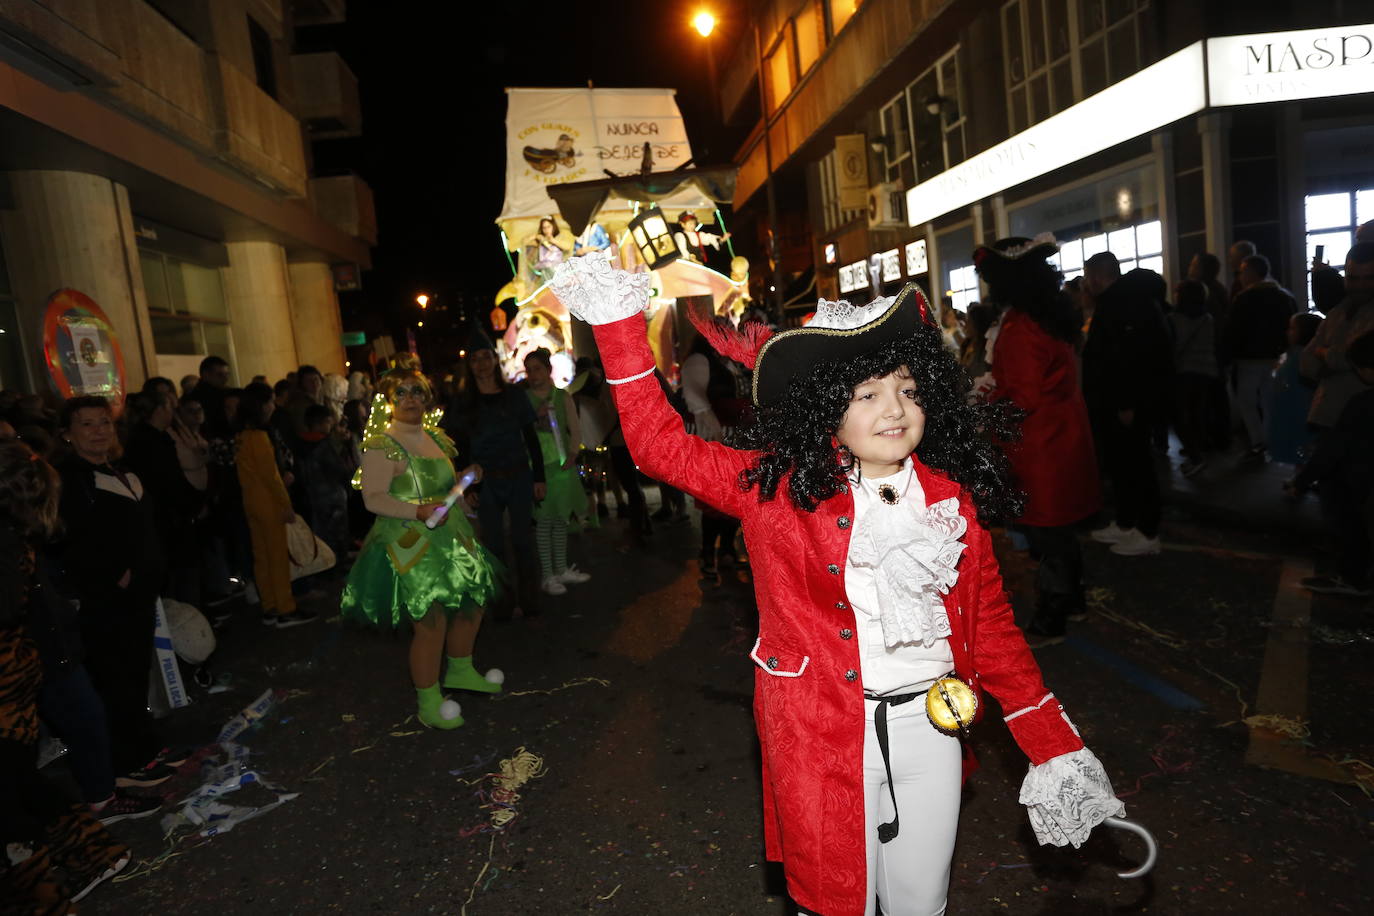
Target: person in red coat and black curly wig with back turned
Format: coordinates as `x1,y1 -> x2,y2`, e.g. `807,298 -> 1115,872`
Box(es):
973,235 -> 1102,648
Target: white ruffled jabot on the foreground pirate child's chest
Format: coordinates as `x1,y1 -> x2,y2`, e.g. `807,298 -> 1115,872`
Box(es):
849,497 -> 969,648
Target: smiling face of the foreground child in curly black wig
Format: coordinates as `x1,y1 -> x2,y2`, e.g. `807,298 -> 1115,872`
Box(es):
835,367 -> 926,477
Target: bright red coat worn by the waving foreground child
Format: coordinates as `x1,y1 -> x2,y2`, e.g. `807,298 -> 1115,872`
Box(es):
595,316 -> 1083,916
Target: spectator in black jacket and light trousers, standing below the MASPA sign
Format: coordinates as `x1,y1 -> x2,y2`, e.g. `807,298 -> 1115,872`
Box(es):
1226,254 -> 1297,464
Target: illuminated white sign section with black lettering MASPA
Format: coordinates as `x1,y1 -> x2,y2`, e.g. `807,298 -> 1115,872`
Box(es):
1206,25 -> 1374,106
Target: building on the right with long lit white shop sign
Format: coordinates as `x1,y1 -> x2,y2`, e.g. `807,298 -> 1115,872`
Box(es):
721,0 -> 1374,317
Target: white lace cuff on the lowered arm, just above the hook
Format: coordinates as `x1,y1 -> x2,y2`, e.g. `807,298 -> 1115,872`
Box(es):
1021,747 -> 1125,849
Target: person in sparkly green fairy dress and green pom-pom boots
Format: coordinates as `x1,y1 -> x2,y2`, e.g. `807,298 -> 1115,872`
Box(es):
342,368 -> 502,729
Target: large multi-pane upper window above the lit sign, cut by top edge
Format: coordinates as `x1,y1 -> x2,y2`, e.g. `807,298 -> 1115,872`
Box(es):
1002,0 -> 1147,133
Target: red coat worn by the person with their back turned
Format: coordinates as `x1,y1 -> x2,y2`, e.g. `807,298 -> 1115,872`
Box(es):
992,309 -> 1102,527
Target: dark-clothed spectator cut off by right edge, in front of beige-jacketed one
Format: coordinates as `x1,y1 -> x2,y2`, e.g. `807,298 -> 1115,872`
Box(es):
1292,332 -> 1374,597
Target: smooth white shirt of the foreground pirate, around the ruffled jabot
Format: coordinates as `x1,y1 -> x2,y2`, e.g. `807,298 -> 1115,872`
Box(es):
845,459 -> 954,696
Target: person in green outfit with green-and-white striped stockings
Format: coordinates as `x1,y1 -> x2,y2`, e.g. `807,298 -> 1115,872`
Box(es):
525,347 -> 591,595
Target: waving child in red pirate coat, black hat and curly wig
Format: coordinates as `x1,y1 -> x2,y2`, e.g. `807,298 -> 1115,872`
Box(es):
552,258 -> 1124,916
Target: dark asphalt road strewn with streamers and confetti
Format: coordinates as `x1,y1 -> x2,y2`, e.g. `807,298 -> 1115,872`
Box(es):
91,497 -> 1374,916
